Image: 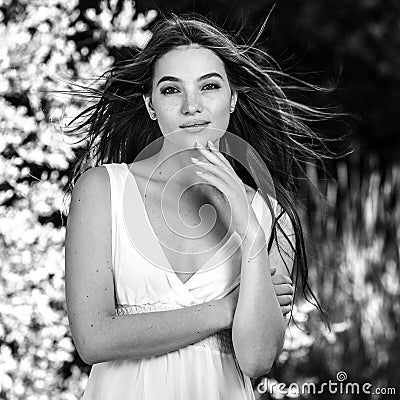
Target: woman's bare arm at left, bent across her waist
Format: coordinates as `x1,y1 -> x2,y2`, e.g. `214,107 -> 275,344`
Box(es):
65,167 -> 231,364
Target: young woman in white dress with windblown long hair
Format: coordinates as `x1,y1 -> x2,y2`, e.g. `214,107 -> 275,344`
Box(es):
65,15 -> 334,400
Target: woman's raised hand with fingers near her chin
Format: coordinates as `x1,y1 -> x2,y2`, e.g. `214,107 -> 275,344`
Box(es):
192,141 -> 261,239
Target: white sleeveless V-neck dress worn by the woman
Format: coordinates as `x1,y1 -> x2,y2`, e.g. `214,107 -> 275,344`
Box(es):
82,163 -> 275,400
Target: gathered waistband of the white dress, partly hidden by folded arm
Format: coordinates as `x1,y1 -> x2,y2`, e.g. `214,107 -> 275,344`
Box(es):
115,303 -> 234,354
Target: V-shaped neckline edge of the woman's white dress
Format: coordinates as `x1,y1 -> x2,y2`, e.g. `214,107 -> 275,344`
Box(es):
123,163 -> 259,289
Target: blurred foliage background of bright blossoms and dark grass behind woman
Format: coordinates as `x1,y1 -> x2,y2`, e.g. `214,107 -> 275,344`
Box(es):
0,0 -> 400,400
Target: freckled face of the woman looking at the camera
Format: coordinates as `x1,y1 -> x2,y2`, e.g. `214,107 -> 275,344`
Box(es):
144,45 -> 236,148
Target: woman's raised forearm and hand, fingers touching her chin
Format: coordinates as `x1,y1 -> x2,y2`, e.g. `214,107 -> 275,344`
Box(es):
188,141 -> 294,377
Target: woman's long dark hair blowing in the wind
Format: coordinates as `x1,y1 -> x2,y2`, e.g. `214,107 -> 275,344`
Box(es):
61,13 -> 350,329
